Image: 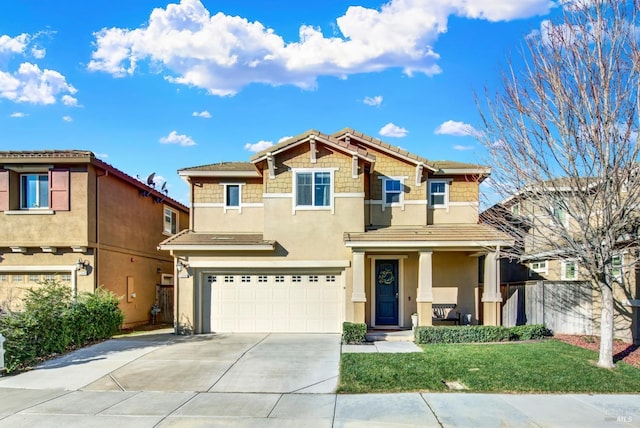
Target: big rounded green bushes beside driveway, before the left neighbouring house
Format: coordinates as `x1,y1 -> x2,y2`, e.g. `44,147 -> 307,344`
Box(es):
0,281 -> 124,373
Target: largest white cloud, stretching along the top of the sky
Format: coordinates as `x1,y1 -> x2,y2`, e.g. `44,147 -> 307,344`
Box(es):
88,0 -> 554,96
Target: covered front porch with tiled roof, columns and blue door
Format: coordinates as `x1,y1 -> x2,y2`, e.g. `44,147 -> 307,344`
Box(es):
345,224 -> 509,329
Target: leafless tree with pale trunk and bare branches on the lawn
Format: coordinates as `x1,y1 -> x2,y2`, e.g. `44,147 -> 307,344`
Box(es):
477,0 -> 640,367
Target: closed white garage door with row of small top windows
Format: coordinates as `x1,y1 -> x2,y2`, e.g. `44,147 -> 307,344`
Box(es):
208,273 -> 344,333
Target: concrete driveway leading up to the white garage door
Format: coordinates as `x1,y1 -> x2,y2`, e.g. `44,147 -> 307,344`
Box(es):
0,332 -> 340,393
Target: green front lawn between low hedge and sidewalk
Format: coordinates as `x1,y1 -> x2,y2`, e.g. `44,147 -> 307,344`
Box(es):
338,340 -> 640,393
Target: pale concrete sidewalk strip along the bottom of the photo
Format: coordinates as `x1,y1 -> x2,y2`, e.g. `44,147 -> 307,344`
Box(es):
0,388 -> 640,428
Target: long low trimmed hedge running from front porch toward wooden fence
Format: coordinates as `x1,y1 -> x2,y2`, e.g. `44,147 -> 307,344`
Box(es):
415,325 -> 551,343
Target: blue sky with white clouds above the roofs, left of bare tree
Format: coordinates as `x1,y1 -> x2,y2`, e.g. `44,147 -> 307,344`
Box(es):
0,0 -> 557,203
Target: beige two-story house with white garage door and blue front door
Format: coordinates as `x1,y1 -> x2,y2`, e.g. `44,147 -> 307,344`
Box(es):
160,129 -> 510,333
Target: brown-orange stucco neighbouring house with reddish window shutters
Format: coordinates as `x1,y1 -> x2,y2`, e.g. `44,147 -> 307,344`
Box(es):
0,150 -> 189,326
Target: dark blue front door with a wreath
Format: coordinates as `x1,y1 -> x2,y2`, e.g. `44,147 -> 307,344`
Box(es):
375,260 -> 398,325
